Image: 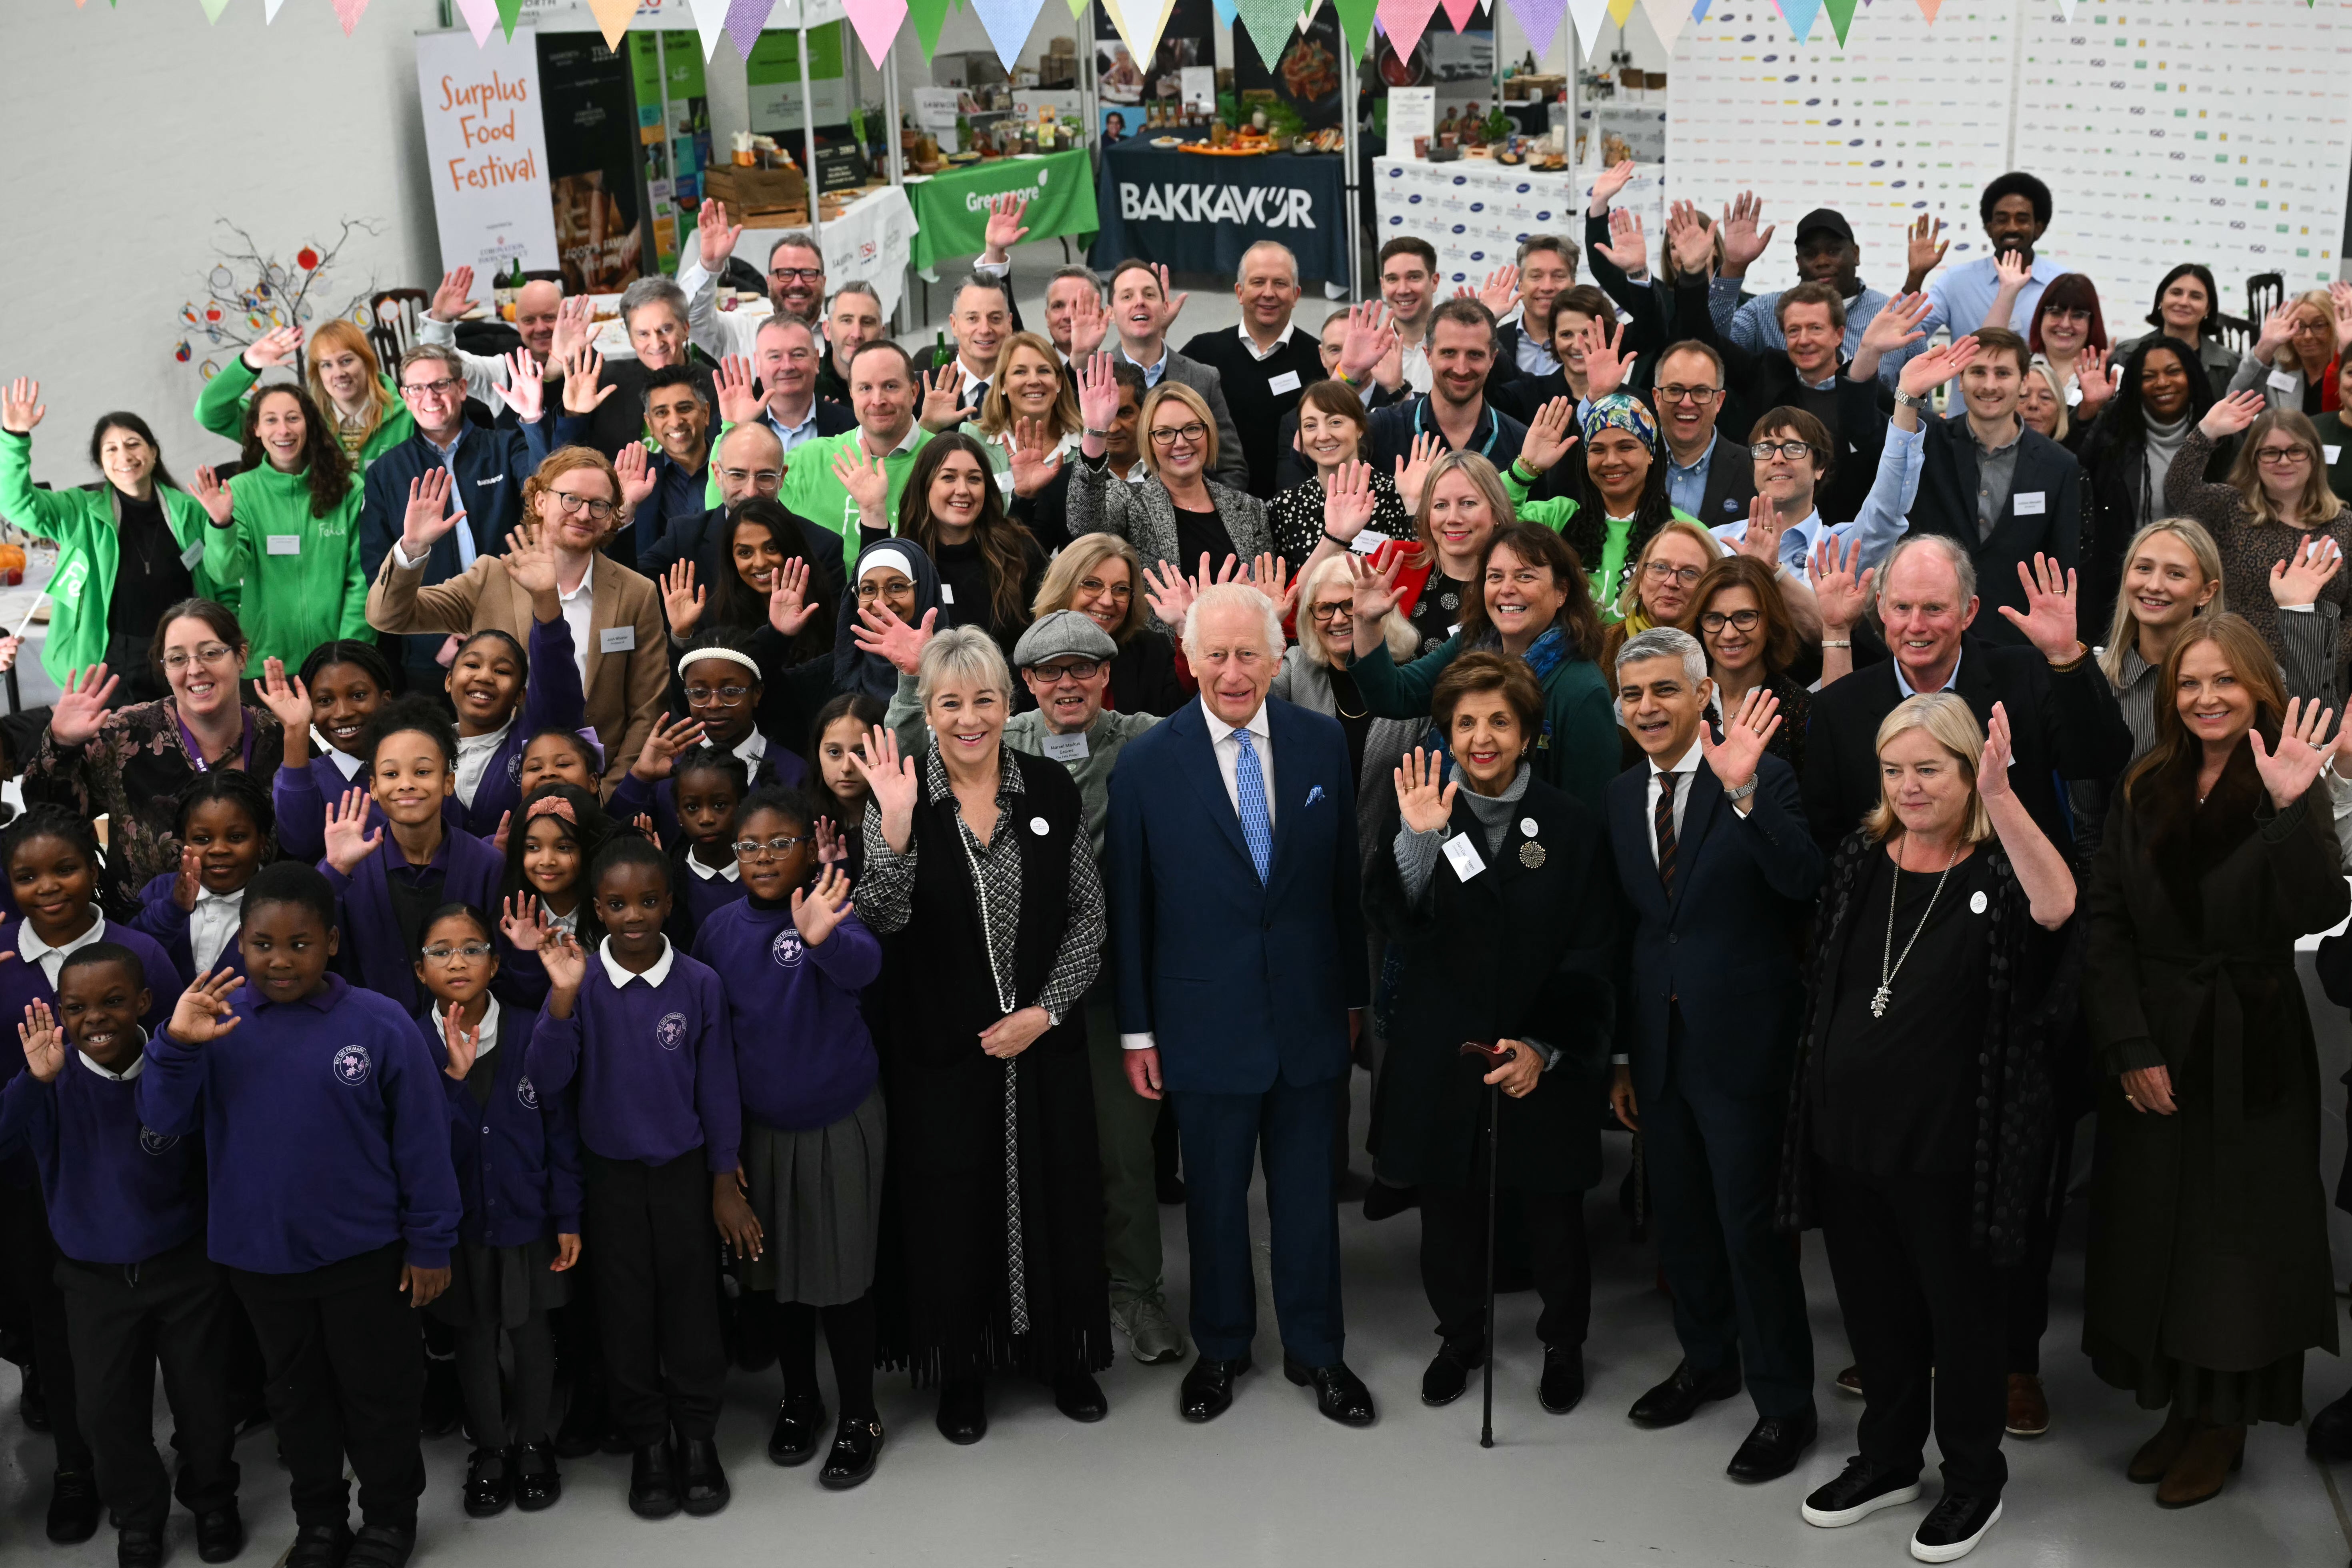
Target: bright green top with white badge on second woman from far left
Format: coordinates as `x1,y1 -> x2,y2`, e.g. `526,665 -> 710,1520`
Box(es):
205,463 -> 374,679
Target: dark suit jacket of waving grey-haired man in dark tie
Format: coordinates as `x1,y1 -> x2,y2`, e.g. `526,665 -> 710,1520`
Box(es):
1609,755 -> 1825,1109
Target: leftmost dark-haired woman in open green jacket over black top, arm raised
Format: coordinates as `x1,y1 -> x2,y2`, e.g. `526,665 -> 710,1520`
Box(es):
0,376 -> 238,703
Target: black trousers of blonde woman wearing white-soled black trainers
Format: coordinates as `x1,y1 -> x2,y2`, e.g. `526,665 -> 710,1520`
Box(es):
1813,1161 -> 2009,1498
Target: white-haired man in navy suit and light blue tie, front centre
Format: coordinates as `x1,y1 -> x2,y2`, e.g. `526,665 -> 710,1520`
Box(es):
1103,583 -> 1374,1427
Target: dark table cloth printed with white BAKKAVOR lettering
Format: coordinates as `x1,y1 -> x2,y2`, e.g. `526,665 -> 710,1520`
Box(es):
1094,141 -> 1348,282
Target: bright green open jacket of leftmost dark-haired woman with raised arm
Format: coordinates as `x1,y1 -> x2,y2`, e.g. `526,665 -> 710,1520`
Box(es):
0,430 -> 238,686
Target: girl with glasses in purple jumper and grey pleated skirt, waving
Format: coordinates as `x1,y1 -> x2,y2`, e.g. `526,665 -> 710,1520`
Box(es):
694,790 -> 884,1490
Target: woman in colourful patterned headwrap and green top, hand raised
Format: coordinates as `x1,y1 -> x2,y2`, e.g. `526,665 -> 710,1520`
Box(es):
1503,392 -> 1696,616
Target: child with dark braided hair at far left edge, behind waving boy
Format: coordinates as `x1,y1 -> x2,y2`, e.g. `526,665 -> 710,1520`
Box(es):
0,804 -> 179,1544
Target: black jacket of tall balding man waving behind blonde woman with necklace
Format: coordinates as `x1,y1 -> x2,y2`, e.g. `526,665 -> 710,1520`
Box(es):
1804,632 -> 2131,851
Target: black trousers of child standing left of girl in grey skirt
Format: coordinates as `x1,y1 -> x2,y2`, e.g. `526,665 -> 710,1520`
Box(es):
581,1150 -> 727,1448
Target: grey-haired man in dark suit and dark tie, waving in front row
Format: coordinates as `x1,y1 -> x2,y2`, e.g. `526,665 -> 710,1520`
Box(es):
1609,628 -> 1823,1481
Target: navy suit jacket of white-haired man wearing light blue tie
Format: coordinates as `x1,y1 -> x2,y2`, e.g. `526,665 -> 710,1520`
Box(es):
1103,698 -> 1371,1096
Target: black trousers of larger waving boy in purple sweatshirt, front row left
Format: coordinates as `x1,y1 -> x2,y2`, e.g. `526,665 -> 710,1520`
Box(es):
228,1241 -> 426,1530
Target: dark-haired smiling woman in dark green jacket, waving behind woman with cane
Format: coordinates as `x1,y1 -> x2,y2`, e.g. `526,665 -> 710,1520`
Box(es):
1348,522 -> 1618,813
